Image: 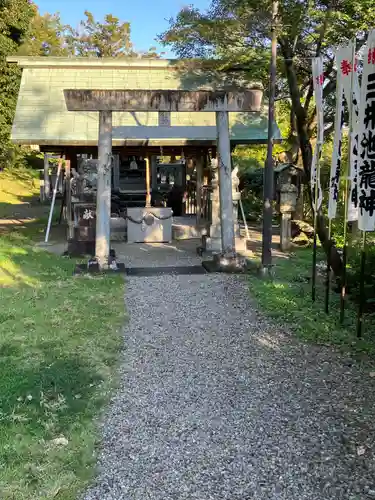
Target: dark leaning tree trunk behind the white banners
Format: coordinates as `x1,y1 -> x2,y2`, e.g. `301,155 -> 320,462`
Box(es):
280,41 -> 343,277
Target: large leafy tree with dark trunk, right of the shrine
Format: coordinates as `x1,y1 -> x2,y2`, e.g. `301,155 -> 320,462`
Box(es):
160,0 -> 375,275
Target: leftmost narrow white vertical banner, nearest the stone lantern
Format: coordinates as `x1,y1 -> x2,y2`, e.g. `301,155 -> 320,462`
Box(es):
310,57 -> 324,211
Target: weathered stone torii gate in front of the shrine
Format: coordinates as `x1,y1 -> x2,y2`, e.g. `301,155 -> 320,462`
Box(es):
64,88 -> 263,269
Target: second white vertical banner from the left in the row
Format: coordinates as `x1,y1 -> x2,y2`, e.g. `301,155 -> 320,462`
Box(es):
328,78 -> 345,219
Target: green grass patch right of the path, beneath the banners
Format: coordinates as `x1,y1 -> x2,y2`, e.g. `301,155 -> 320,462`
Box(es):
250,249 -> 375,355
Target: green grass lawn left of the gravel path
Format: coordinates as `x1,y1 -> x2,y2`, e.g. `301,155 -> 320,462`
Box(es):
0,232 -> 124,500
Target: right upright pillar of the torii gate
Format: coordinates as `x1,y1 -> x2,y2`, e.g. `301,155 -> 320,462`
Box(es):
216,111 -> 236,258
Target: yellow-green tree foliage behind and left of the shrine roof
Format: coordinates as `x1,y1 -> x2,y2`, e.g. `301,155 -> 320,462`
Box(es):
0,4 -> 160,164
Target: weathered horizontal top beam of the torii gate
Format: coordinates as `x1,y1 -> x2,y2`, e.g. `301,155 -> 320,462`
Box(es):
64,88 -> 263,113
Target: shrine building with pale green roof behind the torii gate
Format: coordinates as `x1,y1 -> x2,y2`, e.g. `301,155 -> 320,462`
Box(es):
7,56 -> 281,258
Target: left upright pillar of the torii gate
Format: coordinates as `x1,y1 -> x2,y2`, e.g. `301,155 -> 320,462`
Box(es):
95,111 -> 112,269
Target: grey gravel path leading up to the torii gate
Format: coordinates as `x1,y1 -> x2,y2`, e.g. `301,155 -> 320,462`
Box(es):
84,258 -> 375,500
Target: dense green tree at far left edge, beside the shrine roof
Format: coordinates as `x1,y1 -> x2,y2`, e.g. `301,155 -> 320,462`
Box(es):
0,0 -> 35,163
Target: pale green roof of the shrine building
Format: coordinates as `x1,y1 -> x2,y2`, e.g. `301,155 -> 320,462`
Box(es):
7,57 -> 281,146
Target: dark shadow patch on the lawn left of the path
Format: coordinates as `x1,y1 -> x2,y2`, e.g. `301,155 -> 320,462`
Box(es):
0,356 -> 103,434
